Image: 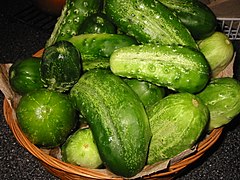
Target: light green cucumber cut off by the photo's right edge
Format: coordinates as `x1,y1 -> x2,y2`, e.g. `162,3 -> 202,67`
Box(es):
197,77 -> 240,131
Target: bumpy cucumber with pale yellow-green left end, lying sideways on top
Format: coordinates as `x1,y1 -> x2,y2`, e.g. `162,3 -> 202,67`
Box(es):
110,44 -> 210,93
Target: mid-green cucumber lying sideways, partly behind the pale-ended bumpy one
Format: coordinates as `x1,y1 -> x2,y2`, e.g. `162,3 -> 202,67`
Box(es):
68,33 -> 137,71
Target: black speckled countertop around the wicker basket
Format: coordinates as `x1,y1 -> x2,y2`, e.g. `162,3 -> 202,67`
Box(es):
0,0 -> 240,180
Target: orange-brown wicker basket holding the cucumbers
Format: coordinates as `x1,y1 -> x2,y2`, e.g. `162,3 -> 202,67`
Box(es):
0,47 -> 232,180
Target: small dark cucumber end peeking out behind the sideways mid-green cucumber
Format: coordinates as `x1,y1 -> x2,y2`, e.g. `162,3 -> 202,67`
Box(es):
79,13 -> 117,34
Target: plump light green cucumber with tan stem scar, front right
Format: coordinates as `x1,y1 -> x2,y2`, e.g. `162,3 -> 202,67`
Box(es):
147,93 -> 209,164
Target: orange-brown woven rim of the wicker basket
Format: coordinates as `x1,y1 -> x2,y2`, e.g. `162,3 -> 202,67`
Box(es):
3,95 -> 223,179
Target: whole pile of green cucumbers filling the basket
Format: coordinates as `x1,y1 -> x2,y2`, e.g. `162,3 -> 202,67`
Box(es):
9,0 -> 240,177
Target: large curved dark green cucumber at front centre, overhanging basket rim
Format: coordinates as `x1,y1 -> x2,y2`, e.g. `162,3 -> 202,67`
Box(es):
70,69 -> 151,177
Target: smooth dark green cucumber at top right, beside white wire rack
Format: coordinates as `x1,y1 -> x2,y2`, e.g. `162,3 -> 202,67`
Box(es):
158,0 -> 217,39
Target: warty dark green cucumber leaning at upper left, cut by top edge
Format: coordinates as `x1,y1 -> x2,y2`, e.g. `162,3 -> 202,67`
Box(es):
45,0 -> 102,47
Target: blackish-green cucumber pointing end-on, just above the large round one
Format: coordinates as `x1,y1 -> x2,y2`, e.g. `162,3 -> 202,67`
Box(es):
40,41 -> 82,92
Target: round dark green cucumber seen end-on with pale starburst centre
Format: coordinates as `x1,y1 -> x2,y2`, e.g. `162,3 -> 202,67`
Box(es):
16,89 -> 77,148
